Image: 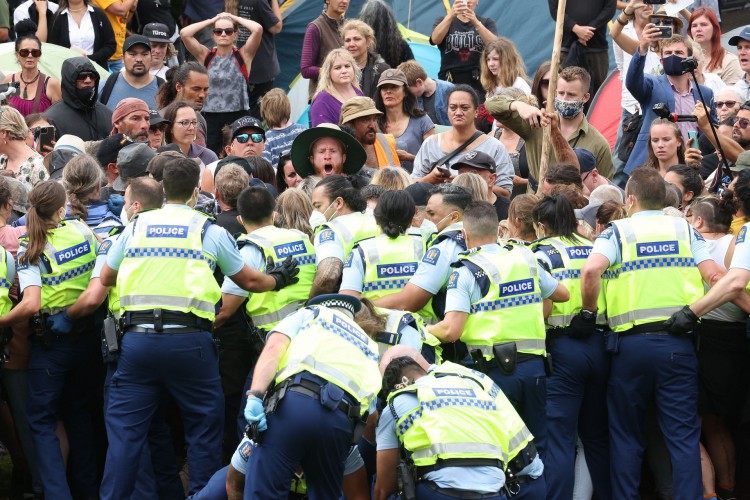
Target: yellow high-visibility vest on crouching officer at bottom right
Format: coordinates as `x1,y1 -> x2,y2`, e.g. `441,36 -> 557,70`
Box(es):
388,374 -> 523,467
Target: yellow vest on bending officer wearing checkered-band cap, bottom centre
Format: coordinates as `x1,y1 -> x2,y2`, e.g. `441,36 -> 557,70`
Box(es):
276,306 -> 381,415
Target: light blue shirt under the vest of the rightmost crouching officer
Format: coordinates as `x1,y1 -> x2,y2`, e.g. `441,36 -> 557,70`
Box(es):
376,377 -> 505,494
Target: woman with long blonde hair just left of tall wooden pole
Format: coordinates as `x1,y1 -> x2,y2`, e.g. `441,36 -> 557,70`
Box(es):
479,36 -> 531,98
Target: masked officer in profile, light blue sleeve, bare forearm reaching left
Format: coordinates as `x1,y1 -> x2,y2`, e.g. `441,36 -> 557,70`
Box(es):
375,184 -> 471,324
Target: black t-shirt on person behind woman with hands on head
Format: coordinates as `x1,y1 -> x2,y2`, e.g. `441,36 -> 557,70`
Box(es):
237,0 -> 281,83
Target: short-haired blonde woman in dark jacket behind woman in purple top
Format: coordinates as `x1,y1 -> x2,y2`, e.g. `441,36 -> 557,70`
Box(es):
339,19 -> 390,97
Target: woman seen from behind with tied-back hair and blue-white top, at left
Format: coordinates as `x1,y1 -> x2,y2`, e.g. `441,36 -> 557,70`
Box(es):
62,154 -> 122,238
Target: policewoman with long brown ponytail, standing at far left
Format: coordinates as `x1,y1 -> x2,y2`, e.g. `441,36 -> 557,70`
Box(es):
0,181 -> 98,499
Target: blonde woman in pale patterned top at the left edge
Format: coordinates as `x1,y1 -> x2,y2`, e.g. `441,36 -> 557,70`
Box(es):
0,106 -> 49,186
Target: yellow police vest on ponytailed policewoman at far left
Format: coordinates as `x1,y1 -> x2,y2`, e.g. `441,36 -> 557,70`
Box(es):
21,219 -> 96,314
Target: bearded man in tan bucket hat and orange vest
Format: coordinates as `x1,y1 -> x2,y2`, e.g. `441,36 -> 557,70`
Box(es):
341,96 -> 401,168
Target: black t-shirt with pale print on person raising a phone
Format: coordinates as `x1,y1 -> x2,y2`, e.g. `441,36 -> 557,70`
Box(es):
430,16 -> 497,83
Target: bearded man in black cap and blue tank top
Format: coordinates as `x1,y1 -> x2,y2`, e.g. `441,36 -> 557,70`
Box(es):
99,35 -> 164,109
